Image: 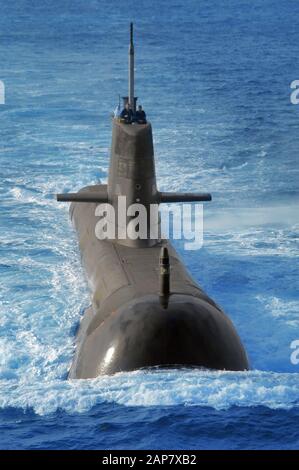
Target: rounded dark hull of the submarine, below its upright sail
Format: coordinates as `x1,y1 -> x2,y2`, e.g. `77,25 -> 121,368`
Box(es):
69,186 -> 249,378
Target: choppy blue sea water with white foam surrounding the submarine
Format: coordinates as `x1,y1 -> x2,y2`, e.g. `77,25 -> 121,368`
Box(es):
0,0 -> 299,449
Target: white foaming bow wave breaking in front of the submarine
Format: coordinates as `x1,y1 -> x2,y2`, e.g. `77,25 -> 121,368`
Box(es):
0,369 -> 299,415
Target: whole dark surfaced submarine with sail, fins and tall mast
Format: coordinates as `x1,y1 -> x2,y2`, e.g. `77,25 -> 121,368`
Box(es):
57,24 -> 249,379
